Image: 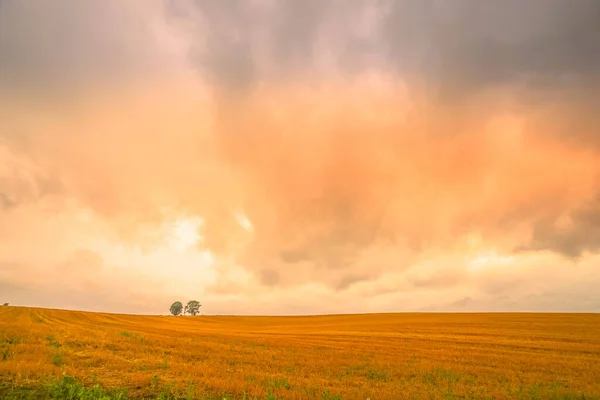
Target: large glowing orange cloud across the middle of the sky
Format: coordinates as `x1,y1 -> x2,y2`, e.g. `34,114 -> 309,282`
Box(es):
5,80 -> 599,310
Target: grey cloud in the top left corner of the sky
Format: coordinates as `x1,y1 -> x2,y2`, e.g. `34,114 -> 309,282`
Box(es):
0,0 -> 180,90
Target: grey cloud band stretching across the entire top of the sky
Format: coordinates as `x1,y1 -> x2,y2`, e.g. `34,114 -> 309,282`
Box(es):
0,0 -> 600,98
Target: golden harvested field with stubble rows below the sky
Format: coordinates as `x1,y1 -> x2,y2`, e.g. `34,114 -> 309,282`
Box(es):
0,306 -> 600,400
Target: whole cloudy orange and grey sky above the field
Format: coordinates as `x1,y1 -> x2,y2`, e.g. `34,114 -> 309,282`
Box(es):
0,0 -> 600,315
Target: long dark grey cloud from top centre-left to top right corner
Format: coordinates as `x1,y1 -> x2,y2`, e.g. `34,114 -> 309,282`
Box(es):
167,0 -> 600,95
